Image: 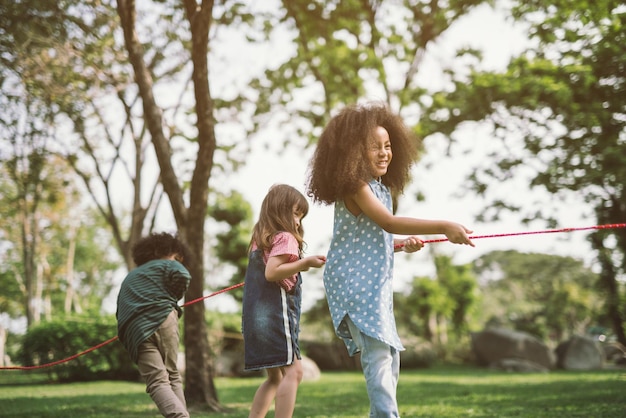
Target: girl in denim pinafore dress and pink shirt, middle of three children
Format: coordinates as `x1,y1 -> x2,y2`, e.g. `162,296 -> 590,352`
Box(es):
242,184 -> 326,418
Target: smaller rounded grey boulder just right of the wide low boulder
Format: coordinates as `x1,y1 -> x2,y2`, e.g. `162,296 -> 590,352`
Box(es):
555,335 -> 605,370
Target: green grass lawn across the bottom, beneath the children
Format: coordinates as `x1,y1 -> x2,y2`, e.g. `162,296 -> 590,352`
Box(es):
0,366 -> 626,418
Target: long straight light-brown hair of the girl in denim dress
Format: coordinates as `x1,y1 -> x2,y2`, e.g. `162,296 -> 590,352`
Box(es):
250,184 -> 309,251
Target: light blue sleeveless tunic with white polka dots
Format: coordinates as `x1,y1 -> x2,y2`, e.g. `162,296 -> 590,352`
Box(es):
324,180 -> 404,353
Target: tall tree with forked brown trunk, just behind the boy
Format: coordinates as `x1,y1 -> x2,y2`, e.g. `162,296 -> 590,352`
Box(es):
1,0 -> 516,409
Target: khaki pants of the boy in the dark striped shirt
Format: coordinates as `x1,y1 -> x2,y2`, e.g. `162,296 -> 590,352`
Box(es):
137,309 -> 189,418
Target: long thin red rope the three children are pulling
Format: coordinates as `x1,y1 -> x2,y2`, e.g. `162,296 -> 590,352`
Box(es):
0,223 -> 626,370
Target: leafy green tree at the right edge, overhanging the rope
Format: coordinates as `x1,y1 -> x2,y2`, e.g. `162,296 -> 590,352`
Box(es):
428,0 -> 626,344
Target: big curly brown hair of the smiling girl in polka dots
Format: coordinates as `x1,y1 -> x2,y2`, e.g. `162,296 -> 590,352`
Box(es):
307,102 -> 419,204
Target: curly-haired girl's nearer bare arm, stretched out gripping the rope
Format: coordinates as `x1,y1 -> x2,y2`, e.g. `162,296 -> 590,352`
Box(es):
346,183 -> 474,247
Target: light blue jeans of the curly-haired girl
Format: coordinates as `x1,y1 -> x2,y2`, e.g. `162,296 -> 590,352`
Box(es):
344,317 -> 400,418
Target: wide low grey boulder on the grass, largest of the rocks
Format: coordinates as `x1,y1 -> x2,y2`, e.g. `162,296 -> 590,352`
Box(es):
471,328 -> 554,370
